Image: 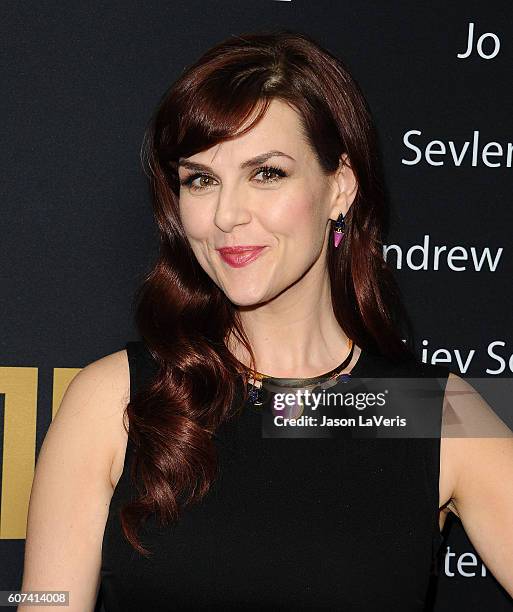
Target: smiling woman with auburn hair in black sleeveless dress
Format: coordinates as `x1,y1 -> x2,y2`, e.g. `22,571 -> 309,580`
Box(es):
20,31 -> 513,612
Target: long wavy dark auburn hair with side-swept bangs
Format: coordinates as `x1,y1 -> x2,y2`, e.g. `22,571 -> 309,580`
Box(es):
120,30 -> 413,555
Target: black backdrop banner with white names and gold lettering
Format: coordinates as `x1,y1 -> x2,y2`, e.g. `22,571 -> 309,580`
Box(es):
0,0 -> 513,611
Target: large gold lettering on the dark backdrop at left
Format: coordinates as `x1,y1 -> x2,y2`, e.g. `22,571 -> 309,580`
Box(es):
0,367 -> 80,540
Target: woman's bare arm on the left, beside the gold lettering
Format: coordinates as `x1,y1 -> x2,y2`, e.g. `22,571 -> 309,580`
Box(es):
18,350 -> 130,612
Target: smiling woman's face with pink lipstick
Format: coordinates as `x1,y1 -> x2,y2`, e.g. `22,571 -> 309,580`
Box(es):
179,99 -> 356,306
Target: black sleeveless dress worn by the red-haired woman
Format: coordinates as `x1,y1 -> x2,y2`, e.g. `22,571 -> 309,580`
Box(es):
99,341 -> 449,612
